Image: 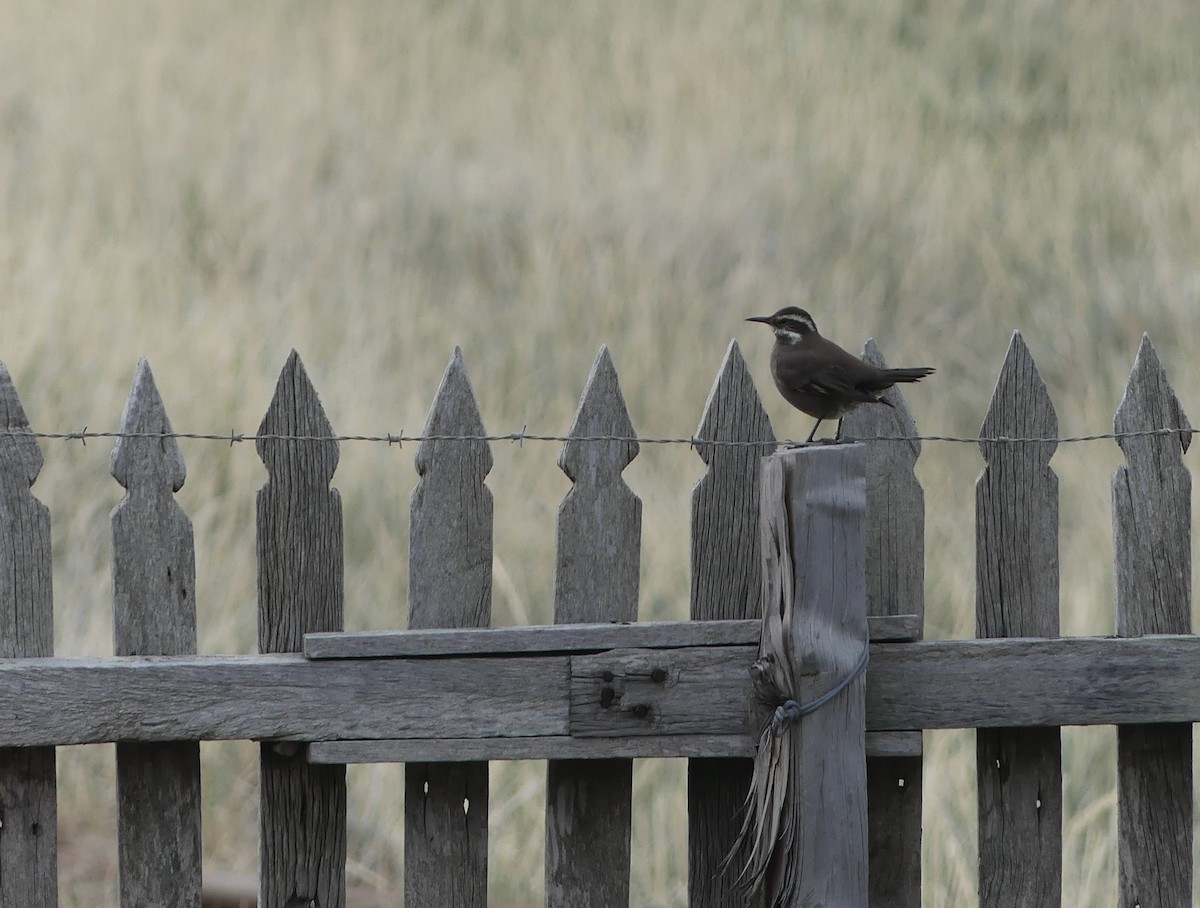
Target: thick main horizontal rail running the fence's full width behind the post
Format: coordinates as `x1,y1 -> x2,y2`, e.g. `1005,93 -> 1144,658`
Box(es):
0,631 -> 1200,759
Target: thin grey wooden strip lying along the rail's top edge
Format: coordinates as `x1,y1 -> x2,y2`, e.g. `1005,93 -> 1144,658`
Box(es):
304,615 -> 920,659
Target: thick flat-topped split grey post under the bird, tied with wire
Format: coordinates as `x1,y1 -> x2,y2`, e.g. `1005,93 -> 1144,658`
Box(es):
756,444 -> 869,908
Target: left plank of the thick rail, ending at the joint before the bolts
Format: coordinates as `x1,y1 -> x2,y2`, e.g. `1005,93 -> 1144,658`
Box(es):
0,647 -> 571,746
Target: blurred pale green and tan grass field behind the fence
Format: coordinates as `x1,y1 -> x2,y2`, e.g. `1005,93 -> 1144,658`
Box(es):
0,0 -> 1200,907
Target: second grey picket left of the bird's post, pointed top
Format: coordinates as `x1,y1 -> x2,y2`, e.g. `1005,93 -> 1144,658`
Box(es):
546,347 -> 642,907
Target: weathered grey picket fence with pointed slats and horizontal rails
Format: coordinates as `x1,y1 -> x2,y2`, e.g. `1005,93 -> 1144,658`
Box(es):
0,335 -> 1200,908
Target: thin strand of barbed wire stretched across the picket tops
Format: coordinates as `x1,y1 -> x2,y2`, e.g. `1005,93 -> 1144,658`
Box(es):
0,426 -> 1200,449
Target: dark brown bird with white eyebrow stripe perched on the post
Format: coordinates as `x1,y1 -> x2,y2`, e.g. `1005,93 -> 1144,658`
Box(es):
746,306 -> 934,441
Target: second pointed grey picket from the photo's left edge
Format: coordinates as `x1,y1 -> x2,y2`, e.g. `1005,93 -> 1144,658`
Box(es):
112,360 -> 202,908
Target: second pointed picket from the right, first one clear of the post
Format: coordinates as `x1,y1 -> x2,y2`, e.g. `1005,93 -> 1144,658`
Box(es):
976,331 -> 1062,908
